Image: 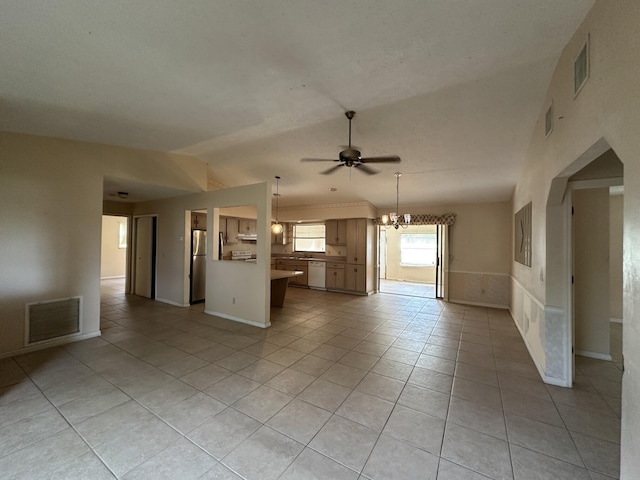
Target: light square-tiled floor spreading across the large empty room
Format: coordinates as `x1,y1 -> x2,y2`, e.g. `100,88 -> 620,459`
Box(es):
0,281 -> 621,480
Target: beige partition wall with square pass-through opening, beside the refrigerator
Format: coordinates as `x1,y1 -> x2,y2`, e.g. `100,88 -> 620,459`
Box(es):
134,183 -> 271,327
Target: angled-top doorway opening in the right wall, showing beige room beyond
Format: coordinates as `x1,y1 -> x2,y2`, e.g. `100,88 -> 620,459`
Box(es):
569,149 -> 624,381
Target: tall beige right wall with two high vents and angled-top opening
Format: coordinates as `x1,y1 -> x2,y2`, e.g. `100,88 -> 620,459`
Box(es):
511,0 -> 640,472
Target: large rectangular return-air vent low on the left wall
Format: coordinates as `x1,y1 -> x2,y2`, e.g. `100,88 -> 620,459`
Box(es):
26,297 -> 82,345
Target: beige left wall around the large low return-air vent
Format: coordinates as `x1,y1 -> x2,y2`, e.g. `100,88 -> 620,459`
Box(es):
0,132 -> 206,356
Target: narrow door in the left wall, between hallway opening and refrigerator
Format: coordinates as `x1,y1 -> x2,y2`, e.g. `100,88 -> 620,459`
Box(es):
133,217 -> 156,298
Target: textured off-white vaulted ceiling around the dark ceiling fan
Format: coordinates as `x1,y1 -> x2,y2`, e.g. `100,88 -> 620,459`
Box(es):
0,0 -> 593,207
